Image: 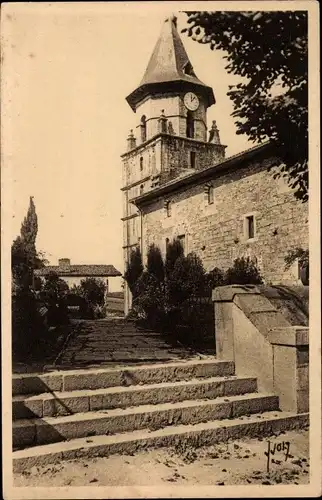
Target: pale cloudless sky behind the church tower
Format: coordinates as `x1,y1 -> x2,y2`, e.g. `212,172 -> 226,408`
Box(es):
3,3 -> 252,278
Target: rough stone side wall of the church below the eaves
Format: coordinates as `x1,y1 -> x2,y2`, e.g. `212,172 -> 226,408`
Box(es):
142,158 -> 308,284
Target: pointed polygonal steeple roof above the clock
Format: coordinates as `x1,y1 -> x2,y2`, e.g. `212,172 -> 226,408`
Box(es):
127,16 -> 215,109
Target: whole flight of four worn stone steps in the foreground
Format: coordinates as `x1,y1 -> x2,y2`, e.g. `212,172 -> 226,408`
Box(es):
12,358 -> 308,472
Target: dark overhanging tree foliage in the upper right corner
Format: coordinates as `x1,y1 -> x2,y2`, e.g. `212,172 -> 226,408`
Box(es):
183,11 -> 308,202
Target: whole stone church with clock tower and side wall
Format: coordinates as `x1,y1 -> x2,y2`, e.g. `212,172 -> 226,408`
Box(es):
122,16 -> 308,313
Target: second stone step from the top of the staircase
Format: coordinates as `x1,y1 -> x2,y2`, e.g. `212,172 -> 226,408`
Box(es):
12,376 -> 257,420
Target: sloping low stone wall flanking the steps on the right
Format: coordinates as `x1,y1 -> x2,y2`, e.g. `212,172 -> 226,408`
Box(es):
213,285 -> 309,413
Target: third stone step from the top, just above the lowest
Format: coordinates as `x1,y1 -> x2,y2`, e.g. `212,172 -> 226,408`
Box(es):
13,393 -> 278,448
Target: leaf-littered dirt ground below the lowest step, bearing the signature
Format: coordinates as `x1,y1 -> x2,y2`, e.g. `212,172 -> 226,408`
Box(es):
14,430 -> 310,487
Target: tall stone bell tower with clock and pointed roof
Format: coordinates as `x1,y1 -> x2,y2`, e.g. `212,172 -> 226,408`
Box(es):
122,16 -> 225,312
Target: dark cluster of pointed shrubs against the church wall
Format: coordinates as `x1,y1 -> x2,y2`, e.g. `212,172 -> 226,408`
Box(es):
128,240 -> 262,347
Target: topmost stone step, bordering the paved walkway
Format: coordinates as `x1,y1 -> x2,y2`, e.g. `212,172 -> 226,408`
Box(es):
12,359 -> 234,396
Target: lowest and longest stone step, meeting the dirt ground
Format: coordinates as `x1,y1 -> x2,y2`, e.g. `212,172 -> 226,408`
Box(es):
12,412 -> 309,473
